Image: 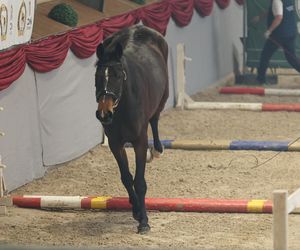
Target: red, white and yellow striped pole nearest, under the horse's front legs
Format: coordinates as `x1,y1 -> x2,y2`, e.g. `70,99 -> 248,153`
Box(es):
12,196 -> 272,213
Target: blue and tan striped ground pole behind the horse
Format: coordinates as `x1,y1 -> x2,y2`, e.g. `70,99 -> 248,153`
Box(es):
145,140 -> 300,151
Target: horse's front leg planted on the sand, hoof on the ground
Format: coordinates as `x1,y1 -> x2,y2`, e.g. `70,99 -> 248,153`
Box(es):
133,134 -> 150,234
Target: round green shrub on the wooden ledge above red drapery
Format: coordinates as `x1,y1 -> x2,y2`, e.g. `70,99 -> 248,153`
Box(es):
48,3 -> 78,27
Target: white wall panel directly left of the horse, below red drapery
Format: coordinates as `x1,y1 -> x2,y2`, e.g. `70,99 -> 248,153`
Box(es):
36,51 -> 102,166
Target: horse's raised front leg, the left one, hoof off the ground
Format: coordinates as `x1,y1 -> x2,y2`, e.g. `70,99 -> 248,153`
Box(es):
109,142 -> 140,221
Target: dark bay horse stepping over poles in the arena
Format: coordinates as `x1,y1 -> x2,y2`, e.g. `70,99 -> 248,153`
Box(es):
96,25 -> 169,233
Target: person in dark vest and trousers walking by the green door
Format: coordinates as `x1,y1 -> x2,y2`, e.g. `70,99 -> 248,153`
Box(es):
256,0 -> 300,84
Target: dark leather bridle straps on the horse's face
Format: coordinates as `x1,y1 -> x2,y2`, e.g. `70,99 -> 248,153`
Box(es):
96,62 -> 127,108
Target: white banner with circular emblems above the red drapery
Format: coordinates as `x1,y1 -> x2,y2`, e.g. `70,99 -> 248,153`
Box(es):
0,0 -> 35,50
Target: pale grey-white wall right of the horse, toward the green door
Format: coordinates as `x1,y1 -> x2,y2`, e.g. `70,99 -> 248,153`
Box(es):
166,1 -> 243,99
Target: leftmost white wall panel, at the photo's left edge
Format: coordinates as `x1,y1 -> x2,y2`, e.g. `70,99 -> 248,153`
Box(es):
0,67 -> 45,190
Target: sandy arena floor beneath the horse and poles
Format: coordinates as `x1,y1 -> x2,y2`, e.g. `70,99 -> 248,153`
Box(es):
0,73 -> 300,250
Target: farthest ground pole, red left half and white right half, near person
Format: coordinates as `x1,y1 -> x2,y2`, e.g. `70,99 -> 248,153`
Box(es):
219,87 -> 300,96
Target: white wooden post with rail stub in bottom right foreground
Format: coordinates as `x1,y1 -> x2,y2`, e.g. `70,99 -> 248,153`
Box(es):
273,188 -> 300,250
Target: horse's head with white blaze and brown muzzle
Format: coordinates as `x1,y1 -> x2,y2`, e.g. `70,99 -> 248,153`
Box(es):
95,43 -> 127,125
